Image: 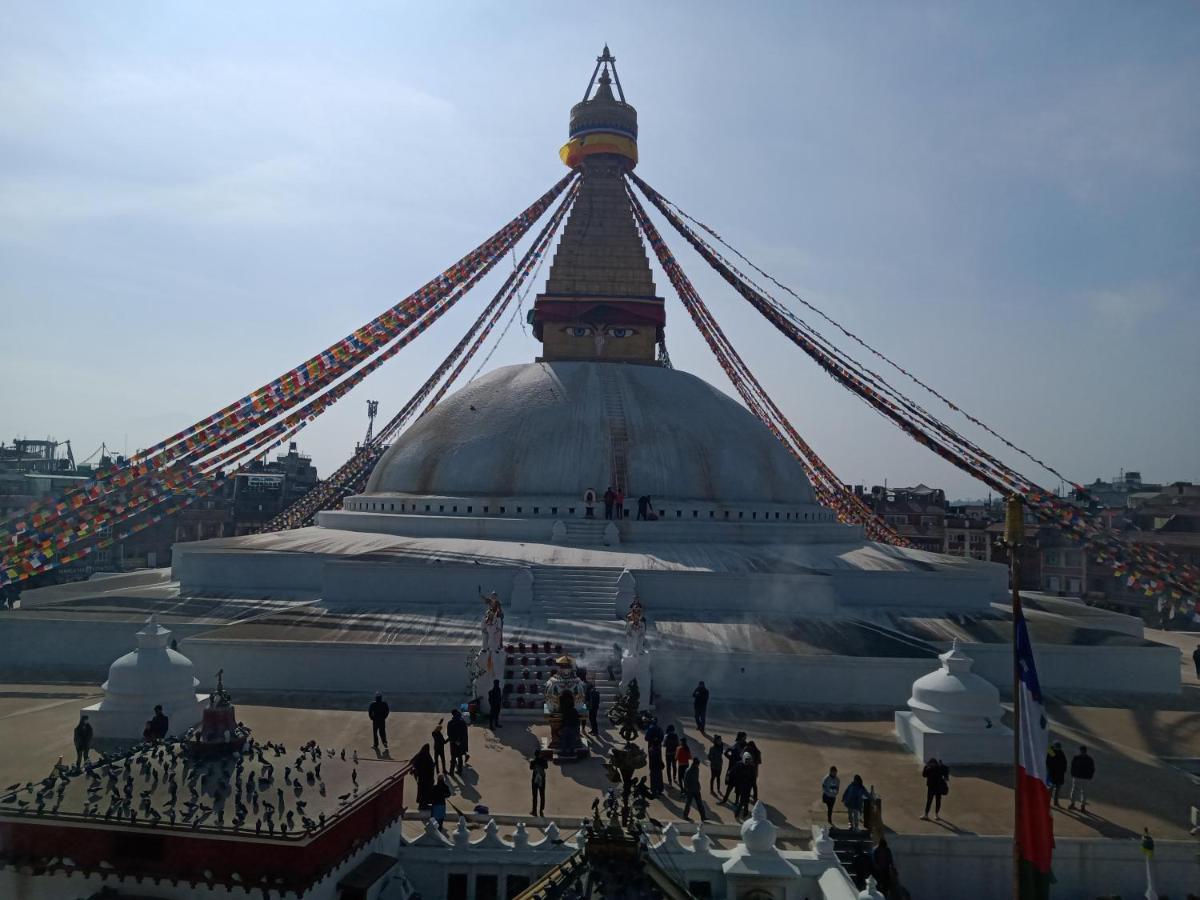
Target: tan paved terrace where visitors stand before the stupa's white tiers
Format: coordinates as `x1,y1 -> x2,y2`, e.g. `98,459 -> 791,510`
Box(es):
0,660 -> 1200,839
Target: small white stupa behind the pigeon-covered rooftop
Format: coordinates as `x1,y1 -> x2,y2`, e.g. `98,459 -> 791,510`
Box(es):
80,616 -> 208,742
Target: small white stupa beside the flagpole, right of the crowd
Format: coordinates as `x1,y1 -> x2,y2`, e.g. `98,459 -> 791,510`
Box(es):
895,641 -> 1013,766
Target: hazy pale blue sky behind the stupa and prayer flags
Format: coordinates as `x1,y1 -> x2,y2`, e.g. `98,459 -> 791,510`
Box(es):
0,1 -> 1200,496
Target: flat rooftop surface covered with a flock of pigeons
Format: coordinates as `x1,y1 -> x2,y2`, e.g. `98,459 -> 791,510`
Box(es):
0,738 -> 372,836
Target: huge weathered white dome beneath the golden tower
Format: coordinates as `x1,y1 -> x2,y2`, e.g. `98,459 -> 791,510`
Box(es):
362,361 -> 815,508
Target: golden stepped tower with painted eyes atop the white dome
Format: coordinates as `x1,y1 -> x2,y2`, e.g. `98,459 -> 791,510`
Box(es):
529,47 -> 665,362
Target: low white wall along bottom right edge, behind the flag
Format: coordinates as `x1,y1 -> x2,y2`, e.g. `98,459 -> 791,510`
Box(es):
888,834 -> 1200,900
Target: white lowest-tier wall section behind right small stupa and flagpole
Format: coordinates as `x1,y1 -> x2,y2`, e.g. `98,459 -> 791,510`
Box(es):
955,643 -> 1181,696
